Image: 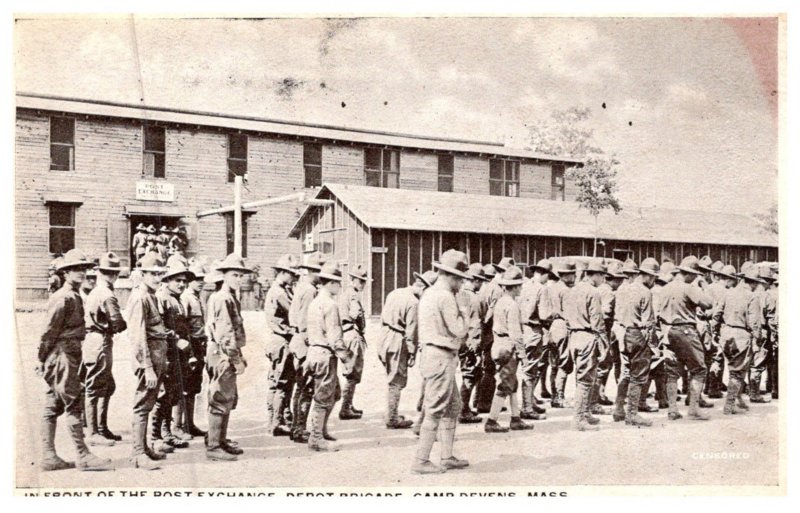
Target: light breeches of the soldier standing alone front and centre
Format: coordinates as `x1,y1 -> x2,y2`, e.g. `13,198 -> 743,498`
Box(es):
420,345 -> 461,426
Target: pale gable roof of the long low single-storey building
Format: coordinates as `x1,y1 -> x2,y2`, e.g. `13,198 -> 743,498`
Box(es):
289,184 -> 778,247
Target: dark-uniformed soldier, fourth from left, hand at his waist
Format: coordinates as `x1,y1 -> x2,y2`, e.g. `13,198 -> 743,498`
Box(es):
151,261 -> 194,449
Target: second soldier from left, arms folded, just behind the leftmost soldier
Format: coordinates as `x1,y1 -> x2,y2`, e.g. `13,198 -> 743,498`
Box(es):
83,253 -> 127,445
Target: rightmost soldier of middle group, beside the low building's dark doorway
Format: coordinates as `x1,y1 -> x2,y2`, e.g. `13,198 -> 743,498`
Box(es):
339,264 -> 370,420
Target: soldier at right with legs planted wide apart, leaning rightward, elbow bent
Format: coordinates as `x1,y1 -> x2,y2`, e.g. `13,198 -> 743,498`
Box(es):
659,255 -> 712,420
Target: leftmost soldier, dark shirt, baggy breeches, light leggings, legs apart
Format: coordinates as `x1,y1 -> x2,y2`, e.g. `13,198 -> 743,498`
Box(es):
37,249 -> 111,471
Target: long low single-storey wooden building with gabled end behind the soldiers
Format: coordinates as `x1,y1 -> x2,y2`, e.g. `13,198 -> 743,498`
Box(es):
290,184 -> 778,314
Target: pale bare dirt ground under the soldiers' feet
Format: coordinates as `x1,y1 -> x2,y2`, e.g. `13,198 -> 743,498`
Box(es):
15,312 -> 780,488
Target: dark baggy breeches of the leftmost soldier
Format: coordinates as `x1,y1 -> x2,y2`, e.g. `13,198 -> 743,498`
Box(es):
43,340 -> 83,422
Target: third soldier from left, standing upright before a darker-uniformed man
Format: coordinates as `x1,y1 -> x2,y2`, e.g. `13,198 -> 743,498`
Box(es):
126,253 -> 174,470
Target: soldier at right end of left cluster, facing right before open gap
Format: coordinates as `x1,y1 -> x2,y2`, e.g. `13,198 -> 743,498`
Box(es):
206,253 -> 250,461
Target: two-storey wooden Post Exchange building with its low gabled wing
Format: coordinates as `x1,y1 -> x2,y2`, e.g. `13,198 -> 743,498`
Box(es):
15,94 -> 777,314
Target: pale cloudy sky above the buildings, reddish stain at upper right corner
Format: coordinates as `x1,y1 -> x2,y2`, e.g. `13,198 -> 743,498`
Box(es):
15,16 -> 780,214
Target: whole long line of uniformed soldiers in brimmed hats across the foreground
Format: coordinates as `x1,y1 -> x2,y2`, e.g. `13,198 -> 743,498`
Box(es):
38,242 -> 778,474
